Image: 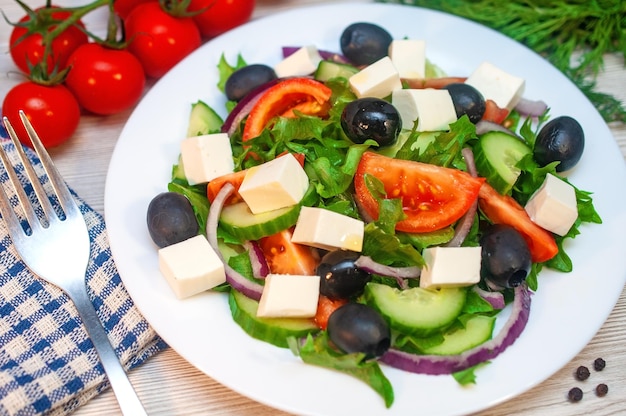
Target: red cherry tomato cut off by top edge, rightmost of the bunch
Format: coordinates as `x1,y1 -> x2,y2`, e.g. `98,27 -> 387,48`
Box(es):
187,0 -> 255,38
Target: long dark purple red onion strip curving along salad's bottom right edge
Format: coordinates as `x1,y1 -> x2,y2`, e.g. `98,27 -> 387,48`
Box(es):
379,284 -> 531,375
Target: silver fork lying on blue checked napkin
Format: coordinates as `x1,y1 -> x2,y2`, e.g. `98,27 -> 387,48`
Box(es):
0,111 -> 146,416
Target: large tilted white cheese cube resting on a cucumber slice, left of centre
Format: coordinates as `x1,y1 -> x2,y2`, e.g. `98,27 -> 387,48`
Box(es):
239,153 -> 309,214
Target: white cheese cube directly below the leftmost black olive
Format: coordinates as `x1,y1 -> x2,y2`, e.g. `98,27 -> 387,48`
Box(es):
158,235 -> 226,299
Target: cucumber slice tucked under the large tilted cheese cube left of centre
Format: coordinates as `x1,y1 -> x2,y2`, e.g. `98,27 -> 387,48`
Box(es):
220,202 -> 300,240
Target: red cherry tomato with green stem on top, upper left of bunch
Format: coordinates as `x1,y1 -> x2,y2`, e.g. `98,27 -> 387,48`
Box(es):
9,6 -> 88,74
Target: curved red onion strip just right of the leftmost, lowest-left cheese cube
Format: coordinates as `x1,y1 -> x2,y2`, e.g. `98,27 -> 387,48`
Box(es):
206,183 -> 263,301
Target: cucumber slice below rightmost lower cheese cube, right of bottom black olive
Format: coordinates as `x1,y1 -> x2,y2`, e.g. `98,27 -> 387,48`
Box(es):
365,282 -> 467,336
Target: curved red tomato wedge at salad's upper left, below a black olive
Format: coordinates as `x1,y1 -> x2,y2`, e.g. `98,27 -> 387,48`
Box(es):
242,78 -> 332,142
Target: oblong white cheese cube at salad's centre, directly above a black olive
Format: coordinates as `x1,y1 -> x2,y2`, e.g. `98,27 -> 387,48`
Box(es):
291,207 -> 365,251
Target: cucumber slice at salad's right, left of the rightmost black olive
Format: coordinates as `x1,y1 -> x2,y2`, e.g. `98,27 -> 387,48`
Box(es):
474,131 -> 532,194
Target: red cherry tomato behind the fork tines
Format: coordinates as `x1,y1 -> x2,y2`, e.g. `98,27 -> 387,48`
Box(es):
2,81 -> 80,147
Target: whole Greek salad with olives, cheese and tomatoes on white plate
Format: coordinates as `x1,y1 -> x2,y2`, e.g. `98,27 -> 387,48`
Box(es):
147,22 -> 601,407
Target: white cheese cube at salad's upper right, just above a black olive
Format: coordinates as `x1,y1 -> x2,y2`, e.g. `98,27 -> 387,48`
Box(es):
465,62 -> 525,110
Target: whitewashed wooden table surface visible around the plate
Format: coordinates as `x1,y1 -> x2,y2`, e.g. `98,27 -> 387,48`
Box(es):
0,0 -> 626,416
